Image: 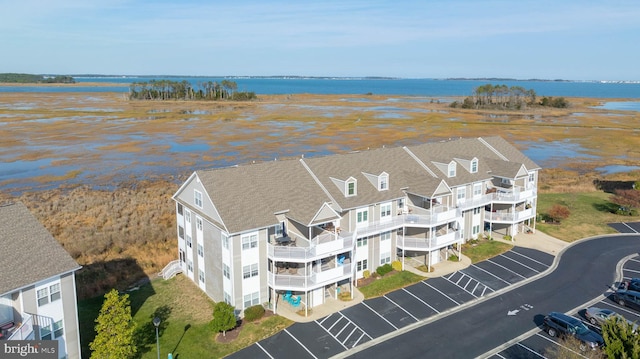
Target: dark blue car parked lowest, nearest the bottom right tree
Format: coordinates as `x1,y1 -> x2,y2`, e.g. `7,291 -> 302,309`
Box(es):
543,312 -> 604,351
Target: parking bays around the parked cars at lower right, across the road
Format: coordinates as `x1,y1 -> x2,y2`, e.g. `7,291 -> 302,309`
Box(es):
490,256 -> 640,359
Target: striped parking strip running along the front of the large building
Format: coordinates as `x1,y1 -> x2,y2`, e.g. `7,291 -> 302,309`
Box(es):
229,247 -> 554,358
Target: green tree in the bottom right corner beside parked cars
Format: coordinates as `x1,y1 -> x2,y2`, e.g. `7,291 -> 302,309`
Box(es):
602,317 -> 640,359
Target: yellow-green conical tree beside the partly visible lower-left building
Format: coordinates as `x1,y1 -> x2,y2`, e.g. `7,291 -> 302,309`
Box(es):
89,289 -> 137,359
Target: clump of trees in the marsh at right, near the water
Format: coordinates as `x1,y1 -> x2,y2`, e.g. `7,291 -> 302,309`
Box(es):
450,84 -> 569,110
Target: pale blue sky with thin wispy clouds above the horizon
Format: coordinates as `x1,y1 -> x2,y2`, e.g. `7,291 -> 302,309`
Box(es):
0,0 -> 640,81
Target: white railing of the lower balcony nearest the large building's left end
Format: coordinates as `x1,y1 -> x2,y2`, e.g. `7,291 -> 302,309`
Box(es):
267,263 -> 353,291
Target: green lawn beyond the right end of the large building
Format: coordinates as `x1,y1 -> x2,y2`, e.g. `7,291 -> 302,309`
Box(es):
536,191 -> 640,242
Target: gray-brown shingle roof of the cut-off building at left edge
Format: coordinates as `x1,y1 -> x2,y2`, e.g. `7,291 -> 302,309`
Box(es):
0,203 -> 80,295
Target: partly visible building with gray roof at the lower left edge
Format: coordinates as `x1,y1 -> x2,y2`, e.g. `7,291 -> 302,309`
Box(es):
0,203 -> 80,358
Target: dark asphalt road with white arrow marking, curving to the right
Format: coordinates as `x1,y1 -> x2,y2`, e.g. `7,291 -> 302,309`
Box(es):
344,235 -> 640,359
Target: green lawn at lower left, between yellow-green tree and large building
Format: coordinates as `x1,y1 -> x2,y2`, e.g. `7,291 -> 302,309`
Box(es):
78,276 -> 292,359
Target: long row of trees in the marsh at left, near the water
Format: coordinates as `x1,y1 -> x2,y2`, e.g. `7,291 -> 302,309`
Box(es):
129,80 -> 257,101
